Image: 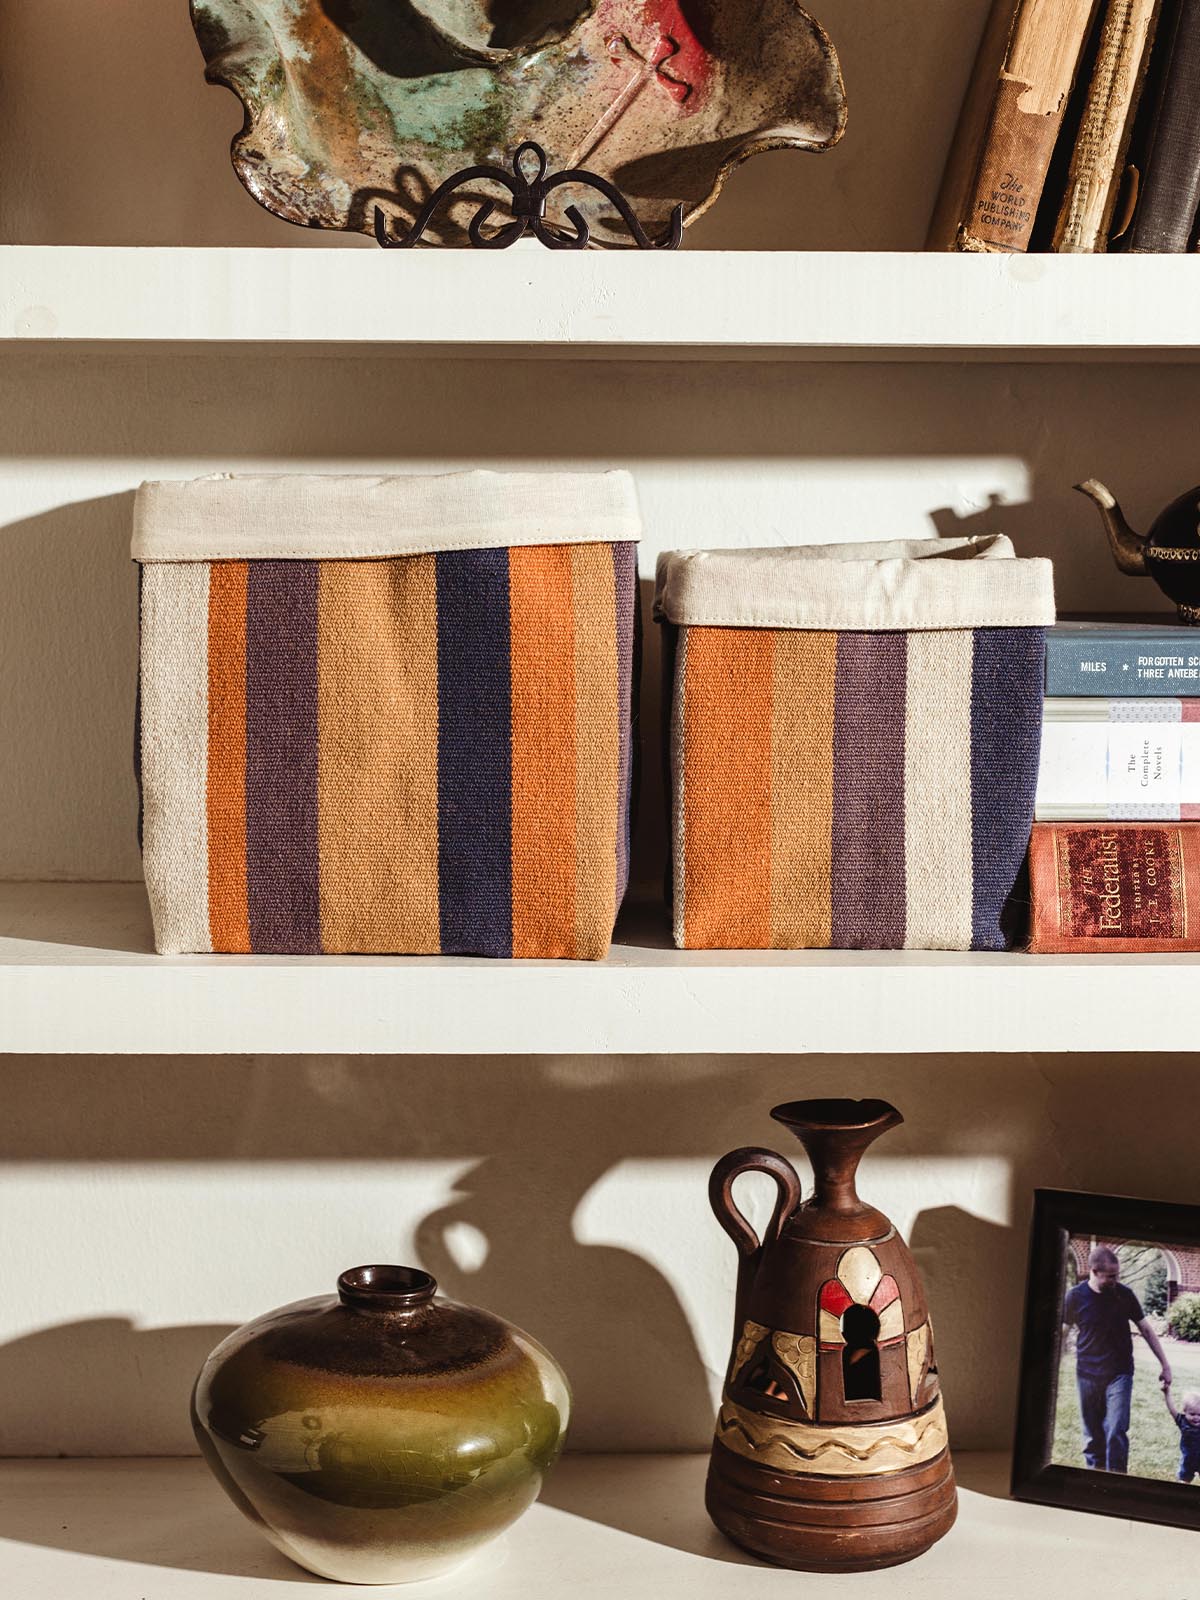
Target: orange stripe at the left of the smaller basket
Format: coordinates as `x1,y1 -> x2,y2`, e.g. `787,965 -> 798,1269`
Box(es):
683,627 -> 774,950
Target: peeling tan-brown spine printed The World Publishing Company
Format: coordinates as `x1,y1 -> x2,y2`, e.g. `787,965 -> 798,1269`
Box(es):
934,0 -> 1096,251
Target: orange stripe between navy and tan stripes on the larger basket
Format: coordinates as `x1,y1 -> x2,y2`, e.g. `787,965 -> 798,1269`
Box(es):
509,544 -> 576,957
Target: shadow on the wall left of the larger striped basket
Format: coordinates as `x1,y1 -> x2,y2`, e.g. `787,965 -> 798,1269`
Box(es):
0,494 -> 141,878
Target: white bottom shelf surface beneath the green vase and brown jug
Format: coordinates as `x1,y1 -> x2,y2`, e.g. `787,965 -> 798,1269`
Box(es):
0,1456 -> 1200,1600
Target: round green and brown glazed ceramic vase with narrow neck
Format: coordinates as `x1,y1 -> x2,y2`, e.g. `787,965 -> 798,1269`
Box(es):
192,1267 -> 571,1584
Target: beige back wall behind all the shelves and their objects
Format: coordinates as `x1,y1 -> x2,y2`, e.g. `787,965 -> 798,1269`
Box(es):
0,0 -> 1198,1453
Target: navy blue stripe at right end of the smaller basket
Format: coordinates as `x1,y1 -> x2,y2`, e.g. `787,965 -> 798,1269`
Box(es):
971,627 -> 1046,950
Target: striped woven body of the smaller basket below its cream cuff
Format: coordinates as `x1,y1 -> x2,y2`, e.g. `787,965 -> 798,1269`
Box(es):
669,627 -> 1045,950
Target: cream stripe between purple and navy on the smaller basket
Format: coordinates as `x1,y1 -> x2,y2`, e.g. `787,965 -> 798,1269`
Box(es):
904,629 -> 974,950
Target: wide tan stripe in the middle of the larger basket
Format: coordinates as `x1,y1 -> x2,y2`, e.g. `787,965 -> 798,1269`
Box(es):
317,555 -> 440,955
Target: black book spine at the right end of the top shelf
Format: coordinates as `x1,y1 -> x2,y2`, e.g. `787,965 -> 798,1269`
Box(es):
1130,0 -> 1200,254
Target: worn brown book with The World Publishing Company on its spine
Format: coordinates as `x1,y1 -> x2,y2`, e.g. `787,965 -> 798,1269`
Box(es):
926,0 -> 1096,251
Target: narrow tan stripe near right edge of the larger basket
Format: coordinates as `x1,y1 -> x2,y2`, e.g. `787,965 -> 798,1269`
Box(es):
571,544 -> 621,960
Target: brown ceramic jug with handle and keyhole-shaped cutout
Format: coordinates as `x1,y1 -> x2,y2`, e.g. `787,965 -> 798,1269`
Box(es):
706,1099 -> 957,1571
